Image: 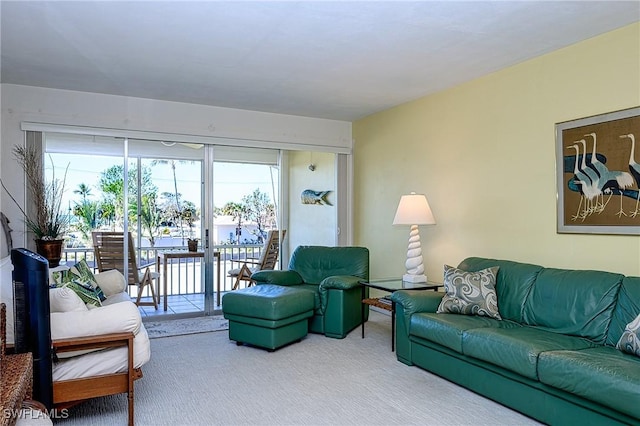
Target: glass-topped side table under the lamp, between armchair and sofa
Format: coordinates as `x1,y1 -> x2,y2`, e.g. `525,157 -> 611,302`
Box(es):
359,278 -> 444,352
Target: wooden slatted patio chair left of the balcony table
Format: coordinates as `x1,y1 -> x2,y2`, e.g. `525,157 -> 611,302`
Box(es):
91,232 -> 160,310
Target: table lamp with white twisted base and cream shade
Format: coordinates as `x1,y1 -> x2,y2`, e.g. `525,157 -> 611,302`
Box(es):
393,192 -> 436,283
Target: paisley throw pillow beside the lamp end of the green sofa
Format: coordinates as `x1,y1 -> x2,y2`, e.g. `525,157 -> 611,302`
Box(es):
436,265 -> 502,320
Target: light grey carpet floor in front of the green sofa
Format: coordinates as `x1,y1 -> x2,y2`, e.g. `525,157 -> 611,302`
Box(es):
55,312 -> 538,426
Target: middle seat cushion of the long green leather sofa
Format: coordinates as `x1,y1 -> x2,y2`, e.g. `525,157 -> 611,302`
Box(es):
462,327 -> 596,380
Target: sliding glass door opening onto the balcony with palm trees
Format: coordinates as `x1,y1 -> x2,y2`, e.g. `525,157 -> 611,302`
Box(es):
44,134 -> 282,317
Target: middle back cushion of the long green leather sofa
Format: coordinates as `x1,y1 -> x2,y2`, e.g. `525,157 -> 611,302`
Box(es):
524,268 -> 623,344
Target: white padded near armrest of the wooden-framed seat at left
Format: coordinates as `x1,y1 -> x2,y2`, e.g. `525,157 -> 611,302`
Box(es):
51,302 -> 142,340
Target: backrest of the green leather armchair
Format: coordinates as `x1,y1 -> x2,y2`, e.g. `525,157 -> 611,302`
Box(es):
289,246 -> 369,284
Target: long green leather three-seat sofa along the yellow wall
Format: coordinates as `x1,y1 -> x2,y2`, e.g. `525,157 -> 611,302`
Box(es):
391,258 -> 640,425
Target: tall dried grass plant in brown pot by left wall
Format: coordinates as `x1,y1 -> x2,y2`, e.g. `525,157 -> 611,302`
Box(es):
2,145 -> 69,268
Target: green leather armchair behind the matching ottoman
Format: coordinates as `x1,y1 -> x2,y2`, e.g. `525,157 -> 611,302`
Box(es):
251,246 -> 369,339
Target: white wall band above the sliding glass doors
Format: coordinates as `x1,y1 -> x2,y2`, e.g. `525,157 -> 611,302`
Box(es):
0,84 -> 352,250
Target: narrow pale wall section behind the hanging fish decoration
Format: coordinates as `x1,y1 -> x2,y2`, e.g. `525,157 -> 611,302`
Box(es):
285,152 -> 337,251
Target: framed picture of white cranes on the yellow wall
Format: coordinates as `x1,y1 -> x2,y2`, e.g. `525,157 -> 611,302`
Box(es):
555,107 -> 640,235
